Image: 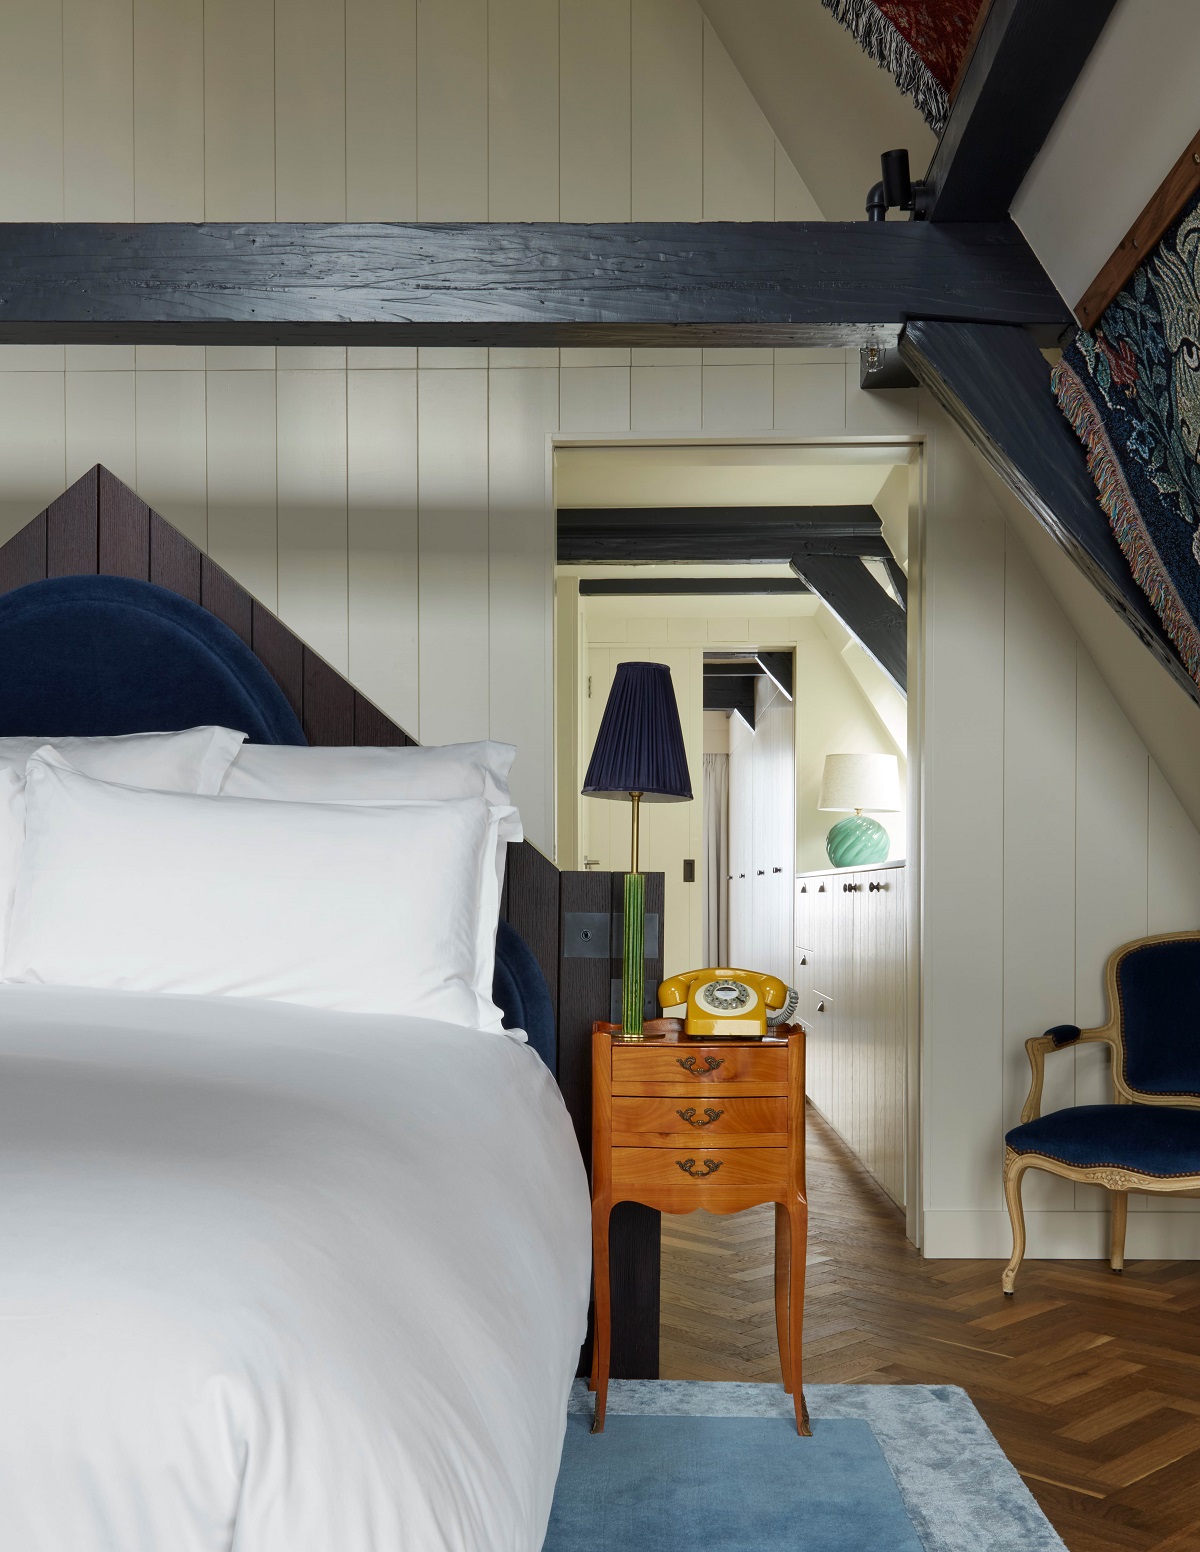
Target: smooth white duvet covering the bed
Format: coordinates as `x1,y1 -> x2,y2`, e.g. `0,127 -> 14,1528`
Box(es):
0,987 -> 590,1552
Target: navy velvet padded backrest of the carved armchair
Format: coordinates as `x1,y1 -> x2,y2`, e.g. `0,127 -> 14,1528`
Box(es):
1116,939 -> 1200,1096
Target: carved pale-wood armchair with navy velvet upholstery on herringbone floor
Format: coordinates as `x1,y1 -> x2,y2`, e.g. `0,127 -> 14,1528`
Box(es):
1001,933 -> 1200,1293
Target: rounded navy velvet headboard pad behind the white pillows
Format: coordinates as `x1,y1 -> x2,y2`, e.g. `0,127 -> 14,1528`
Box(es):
0,576 -> 556,1072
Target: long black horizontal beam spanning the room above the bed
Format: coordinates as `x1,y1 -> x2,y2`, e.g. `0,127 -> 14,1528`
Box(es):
0,219 -> 1070,346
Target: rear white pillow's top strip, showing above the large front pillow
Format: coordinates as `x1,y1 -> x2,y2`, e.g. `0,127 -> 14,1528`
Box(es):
220,739 -> 520,813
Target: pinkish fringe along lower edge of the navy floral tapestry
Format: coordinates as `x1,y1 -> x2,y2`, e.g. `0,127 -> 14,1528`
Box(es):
1049,360 -> 1200,684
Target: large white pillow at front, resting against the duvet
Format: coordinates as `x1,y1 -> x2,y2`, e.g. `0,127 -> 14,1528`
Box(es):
3,750 -> 506,1027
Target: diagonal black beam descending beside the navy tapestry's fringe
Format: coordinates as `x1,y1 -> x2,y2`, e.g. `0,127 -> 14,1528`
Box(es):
900,323 -> 1200,702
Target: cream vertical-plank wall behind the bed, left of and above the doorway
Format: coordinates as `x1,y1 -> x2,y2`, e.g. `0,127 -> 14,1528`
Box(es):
0,0 -> 825,849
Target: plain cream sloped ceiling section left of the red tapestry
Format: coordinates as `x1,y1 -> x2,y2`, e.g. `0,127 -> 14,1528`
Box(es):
700,0 -> 936,220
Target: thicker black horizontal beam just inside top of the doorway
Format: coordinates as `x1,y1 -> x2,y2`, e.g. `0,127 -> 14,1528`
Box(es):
559,506 -> 890,565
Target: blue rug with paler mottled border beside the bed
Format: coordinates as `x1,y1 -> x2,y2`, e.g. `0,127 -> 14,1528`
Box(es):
543,1380 -> 1065,1552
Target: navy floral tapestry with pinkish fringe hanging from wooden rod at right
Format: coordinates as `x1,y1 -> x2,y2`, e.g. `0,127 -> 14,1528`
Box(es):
1051,196 -> 1200,683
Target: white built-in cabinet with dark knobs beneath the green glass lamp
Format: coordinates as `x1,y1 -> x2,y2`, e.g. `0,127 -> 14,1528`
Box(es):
792,863 -> 908,1206
